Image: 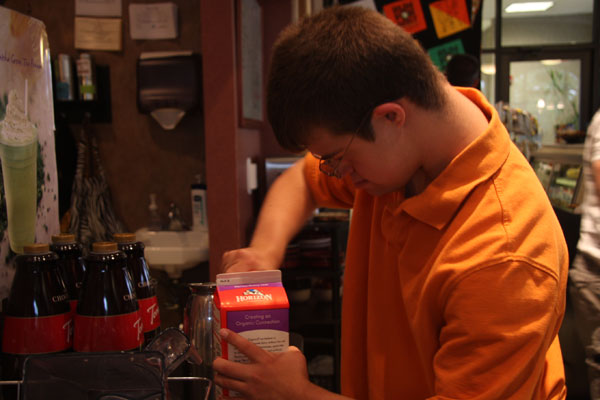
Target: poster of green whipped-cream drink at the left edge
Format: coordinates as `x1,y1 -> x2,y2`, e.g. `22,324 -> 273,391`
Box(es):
0,7 -> 60,299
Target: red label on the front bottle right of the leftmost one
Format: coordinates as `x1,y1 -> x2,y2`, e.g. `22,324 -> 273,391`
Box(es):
73,311 -> 144,352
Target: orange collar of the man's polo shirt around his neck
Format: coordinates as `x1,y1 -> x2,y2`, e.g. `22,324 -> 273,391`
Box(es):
388,88 -> 511,229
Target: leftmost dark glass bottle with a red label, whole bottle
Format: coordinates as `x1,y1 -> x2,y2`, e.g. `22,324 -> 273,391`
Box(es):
1,243 -> 72,399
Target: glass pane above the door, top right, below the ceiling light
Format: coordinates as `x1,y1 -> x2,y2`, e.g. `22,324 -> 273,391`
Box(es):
500,0 -> 594,46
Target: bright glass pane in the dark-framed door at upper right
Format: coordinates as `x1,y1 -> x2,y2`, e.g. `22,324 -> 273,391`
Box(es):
509,60 -> 581,144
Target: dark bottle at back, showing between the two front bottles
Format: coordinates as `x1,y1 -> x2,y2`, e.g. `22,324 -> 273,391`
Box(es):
50,233 -> 85,313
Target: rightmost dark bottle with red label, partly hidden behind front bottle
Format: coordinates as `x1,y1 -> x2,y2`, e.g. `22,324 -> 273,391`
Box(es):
113,233 -> 160,344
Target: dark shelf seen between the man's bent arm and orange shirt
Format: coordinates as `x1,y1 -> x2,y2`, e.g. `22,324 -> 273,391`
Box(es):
281,218 -> 348,392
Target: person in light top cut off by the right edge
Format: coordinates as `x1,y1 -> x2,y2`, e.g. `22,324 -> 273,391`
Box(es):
569,110 -> 600,400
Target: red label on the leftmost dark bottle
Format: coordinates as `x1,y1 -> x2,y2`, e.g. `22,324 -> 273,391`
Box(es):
2,313 -> 73,354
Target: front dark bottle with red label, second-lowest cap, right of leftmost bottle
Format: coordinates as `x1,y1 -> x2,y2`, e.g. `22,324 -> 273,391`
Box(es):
73,242 -> 144,352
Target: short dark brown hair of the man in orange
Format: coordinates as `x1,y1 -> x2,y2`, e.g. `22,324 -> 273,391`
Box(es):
267,6 -> 444,151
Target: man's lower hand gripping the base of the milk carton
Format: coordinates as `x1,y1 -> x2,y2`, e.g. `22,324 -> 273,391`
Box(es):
213,329 -> 314,400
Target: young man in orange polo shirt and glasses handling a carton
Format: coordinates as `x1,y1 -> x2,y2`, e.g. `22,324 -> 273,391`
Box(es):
214,7 -> 568,400
